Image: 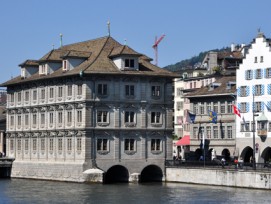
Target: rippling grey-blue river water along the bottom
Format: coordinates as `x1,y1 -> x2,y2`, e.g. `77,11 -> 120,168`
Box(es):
0,179 -> 271,204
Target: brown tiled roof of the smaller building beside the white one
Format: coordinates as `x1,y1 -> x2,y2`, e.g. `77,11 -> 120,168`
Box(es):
186,76 -> 236,98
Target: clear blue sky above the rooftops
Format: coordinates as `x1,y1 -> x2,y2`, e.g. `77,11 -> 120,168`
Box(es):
0,0 -> 271,83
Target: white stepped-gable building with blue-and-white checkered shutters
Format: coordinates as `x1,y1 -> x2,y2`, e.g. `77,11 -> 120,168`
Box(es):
236,33 -> 271,162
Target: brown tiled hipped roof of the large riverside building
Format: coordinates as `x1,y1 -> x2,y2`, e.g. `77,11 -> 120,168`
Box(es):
0,37 -> 178,86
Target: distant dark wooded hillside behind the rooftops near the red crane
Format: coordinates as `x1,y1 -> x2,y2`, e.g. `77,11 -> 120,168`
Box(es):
164,47 -> 230,72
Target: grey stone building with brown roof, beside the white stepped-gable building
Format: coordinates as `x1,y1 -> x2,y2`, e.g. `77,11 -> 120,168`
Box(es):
185,76 -> 237,159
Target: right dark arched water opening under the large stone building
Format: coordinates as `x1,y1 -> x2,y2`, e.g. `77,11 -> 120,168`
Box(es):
140,165 -> 163,182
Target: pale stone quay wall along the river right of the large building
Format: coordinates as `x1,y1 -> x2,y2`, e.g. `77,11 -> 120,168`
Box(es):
166,168 -> 271,189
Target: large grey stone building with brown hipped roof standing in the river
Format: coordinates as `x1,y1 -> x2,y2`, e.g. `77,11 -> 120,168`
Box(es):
1,36 -> 175,182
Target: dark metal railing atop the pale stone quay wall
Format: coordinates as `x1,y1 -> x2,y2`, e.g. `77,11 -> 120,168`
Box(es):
165,160 -> 271,172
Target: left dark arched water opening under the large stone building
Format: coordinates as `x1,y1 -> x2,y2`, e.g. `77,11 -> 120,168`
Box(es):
104,165 -> 129,184
